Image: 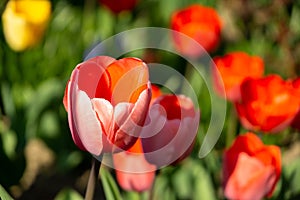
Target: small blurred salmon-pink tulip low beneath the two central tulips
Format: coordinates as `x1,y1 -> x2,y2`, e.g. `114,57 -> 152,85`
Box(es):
113,139 -> 156,192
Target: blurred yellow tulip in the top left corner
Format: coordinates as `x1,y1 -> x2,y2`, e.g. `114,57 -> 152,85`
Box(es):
2,0 -> 51,51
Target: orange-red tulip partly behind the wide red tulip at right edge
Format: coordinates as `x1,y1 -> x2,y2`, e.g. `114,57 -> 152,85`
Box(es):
213,52 -> 264,101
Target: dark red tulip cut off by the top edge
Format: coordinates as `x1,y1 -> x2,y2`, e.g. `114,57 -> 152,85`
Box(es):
99,0 -> 138,14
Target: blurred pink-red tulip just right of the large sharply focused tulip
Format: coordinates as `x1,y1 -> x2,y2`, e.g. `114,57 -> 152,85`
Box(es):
141,95 -> 200,167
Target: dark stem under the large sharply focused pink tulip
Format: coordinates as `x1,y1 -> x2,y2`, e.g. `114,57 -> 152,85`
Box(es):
85,157 -> 101,200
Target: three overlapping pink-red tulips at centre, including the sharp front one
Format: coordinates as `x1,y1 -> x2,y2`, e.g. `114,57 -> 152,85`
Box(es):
63,56 -> 199,191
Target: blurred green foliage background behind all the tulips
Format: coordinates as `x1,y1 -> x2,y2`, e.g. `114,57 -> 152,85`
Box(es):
0,0 -> 300,199
